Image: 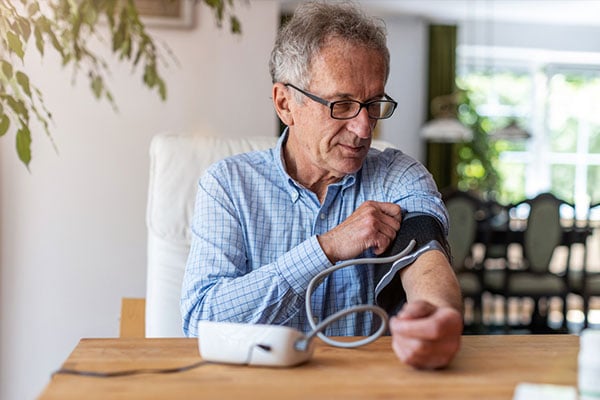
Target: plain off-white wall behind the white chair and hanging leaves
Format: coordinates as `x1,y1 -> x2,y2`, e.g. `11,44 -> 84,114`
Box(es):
0,0 -> 279,400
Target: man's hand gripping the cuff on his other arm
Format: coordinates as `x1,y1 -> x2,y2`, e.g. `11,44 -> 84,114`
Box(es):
318,200 -> 402,263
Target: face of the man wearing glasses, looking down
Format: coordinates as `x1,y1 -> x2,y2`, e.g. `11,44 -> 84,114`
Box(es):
288,39 -> 386,178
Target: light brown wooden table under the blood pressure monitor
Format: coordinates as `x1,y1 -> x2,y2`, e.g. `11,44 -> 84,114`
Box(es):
40,335 -> 579,400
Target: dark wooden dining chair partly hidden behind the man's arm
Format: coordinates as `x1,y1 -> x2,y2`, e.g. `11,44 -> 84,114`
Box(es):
443,190 -> 483,331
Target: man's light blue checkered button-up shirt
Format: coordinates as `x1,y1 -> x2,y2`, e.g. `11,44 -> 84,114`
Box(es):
181,134 -> 448,336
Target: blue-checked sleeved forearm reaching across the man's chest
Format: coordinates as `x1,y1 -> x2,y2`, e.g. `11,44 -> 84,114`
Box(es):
181,237 -> 328,336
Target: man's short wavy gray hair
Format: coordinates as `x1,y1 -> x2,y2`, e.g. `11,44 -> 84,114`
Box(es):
269,2 -> 390,88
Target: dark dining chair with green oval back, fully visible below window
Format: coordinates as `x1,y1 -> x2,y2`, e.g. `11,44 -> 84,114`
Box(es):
484,193 -> 570,333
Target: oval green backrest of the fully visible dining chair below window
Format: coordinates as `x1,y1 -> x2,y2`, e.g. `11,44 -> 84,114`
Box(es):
515,193 -> 566,273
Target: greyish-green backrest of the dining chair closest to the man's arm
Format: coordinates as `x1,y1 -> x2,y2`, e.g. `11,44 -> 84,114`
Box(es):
444,191 -> 479,271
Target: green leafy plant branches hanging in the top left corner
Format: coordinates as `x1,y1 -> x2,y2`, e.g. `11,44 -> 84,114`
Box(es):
0,0 -> 241,168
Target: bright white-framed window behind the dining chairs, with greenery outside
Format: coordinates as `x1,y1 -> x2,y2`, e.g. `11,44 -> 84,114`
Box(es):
457,47 -> 600,216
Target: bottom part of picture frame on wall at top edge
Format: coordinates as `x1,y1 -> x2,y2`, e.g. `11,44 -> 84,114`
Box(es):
134,0 -> 196,29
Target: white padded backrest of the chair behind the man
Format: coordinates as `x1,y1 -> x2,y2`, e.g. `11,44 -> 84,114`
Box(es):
146,133 -> 392,337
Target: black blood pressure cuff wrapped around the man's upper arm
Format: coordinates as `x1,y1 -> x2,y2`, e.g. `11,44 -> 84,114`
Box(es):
375,213 -> 451,316
